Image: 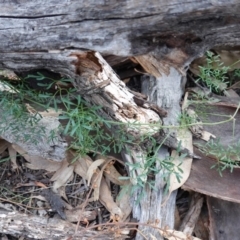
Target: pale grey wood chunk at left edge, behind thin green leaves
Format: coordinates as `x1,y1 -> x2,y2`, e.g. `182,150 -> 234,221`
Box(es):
0,107 -> 68,162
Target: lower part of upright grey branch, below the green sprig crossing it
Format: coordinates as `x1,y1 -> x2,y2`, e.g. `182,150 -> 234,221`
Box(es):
129,147 -> 177,239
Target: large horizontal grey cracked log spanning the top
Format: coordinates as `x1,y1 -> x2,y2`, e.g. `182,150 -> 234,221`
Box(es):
0,0 -> 240,56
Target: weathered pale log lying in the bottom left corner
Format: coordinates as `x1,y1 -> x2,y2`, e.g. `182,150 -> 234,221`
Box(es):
0,210 -> 124,240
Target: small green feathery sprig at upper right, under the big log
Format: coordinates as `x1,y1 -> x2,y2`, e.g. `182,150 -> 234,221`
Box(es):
197,51 -> 230,93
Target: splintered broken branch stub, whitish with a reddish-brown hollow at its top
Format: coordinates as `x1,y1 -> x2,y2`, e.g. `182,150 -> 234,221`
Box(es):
71,52 -> 161,136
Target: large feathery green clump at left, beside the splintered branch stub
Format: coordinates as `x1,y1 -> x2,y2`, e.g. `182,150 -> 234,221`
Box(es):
0,73 -> 142,155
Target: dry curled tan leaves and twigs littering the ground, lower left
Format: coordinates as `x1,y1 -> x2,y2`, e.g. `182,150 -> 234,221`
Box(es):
0,139 -> 131,235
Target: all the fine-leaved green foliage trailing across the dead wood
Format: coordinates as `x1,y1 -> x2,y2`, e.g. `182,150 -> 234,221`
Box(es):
0,52 -> 240,202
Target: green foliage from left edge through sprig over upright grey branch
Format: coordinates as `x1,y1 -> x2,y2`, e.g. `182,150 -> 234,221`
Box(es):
0,73 -> 186,199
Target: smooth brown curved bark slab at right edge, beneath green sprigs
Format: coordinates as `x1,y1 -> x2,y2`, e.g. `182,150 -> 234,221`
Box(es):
184,103 -> 240,203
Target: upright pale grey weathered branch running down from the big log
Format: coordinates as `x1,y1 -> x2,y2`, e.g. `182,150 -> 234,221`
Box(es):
133,66 -> 185,239
